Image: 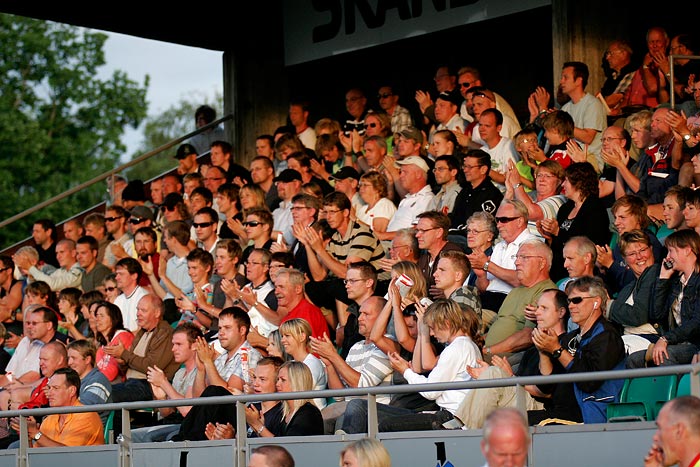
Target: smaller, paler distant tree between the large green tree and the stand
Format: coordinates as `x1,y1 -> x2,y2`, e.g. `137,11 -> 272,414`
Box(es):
126,92 -> 223,182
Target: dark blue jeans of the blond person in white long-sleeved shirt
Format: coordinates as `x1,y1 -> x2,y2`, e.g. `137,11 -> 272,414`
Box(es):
342,399 -> 454,433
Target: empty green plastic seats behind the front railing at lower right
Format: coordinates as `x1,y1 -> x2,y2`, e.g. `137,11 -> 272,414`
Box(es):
607,373 -> 691,423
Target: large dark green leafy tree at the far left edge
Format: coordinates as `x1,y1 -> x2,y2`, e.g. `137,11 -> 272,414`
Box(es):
0,14 -> 148,247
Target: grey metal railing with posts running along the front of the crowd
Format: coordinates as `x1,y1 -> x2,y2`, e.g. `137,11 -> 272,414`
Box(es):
0,364 -> 700,467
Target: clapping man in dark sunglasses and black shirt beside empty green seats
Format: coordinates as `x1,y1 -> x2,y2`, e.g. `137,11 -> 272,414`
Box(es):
532,276 -> 625,423
